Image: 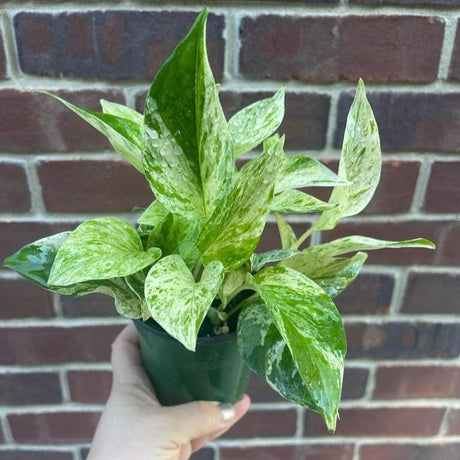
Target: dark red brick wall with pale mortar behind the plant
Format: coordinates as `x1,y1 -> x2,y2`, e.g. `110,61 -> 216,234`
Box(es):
0,0 -> 460,460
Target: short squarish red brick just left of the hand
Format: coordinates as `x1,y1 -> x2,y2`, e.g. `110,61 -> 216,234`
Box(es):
67,371 -> 112,404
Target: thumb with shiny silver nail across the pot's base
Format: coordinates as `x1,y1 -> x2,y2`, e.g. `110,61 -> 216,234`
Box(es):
162,395 -> 251,443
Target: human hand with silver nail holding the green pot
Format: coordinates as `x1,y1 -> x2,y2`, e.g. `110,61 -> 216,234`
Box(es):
88,323 -> 250,460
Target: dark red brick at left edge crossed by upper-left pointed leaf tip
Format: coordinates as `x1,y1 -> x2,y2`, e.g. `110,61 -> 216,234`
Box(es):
0,89 -> 124,153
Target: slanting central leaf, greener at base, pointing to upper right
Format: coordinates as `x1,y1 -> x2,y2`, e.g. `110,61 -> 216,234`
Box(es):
197,138 -> 284,271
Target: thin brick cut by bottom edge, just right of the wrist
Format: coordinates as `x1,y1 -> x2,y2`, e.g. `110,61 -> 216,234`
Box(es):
220,444 -> 354,460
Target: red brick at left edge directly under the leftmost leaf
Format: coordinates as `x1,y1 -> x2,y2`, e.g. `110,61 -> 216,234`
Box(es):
0,278 -> 54,319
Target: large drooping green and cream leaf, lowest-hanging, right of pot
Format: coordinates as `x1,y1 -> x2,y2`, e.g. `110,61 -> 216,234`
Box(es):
240,266 -> 346,430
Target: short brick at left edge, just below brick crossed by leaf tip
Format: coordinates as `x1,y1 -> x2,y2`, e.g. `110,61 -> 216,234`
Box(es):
0,163 -> 30,212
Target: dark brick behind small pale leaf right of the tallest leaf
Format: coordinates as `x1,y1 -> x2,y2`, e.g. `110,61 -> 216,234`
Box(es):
220,92 -> 329,150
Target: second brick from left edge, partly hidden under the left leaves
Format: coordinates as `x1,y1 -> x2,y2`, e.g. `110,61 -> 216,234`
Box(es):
61,294 -> 118,318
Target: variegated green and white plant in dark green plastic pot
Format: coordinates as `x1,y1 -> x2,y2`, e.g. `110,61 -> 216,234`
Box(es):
5,9 -> 434,430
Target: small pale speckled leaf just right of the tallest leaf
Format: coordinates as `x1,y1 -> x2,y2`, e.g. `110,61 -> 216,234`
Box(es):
228,88 -> 284,158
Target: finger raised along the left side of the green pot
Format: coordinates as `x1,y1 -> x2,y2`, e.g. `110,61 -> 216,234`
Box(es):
112,323 -> 157,392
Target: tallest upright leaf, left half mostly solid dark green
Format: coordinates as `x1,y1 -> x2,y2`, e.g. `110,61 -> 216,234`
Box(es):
143,9 -> 235,218
